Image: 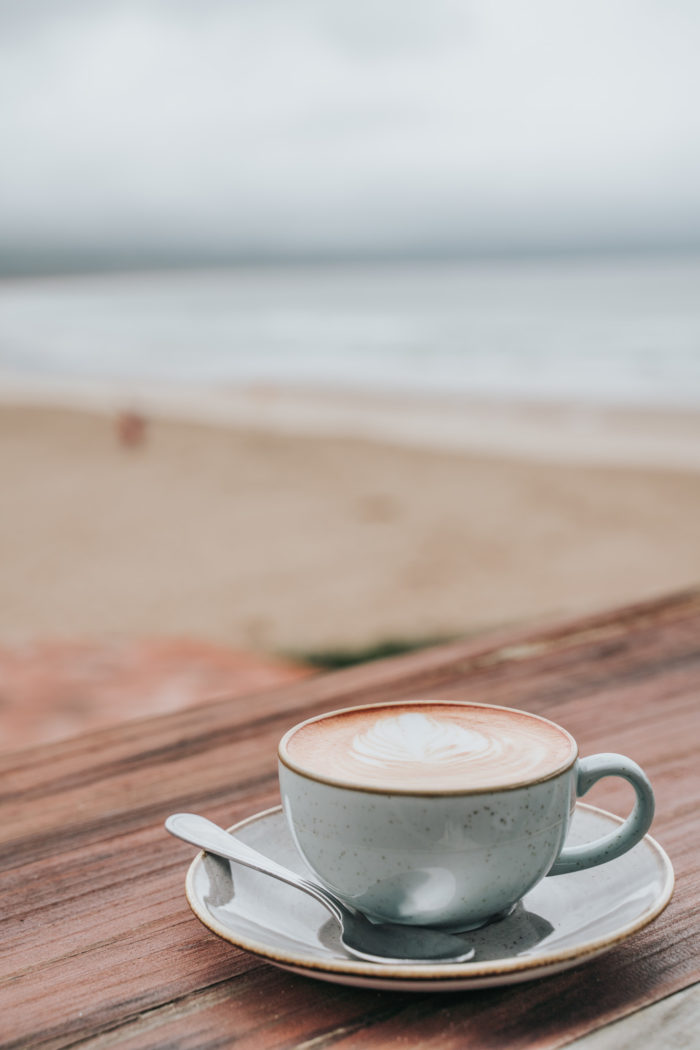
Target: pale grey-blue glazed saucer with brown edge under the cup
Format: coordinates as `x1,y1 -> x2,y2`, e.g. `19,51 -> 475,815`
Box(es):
186,802 -> 674,991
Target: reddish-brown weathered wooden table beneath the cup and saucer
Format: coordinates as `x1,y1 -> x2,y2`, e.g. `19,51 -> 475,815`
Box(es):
0,591 -> 700,1050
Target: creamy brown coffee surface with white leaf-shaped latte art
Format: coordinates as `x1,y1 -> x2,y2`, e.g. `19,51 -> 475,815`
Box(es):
287,702 -> 576,791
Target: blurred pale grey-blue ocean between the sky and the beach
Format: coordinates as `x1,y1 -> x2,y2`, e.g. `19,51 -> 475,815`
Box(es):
0,257 -> 700,408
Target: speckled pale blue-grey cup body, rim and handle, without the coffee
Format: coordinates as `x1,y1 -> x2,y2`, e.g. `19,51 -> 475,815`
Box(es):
279,700 -> 654,929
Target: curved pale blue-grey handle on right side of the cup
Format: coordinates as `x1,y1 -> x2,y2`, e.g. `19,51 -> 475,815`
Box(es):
548,754 -> 654,875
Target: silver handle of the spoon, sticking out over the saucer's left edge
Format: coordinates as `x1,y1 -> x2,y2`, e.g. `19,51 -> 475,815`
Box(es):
165,813 -> 342,922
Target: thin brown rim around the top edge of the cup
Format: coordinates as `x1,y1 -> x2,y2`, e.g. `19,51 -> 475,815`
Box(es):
277,699 -> 578,798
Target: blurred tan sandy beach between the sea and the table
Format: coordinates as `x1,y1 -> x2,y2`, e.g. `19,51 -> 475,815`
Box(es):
0,391 -> 700,653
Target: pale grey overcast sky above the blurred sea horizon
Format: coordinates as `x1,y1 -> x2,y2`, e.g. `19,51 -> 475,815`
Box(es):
0,0 -> 700,272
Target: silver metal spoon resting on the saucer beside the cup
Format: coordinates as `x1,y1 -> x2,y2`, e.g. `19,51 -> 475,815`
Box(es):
165,813 -> 474,965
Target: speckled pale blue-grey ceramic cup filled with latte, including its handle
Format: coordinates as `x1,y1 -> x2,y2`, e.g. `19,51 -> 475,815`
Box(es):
279,700 -> 654,929
